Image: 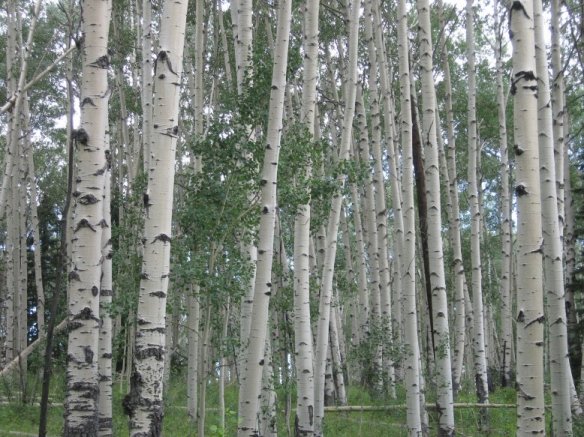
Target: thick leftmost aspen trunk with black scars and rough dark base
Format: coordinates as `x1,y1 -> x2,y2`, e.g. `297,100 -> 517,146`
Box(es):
63,0 -> 111,436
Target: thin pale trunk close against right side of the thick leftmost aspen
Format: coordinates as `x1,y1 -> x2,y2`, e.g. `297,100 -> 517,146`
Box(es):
98,137 -> 113,437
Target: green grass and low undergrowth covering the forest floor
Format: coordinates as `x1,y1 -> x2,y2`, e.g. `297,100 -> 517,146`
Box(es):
0,374 -> 584,437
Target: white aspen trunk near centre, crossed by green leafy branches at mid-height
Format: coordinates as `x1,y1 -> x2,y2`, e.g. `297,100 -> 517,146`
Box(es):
294,0 -> 319,430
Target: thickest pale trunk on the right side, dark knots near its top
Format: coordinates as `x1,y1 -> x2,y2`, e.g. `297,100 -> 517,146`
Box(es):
509,0 -> 545,435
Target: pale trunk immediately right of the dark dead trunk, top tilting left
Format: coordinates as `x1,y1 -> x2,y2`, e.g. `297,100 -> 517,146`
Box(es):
416,0 -> 454,435
